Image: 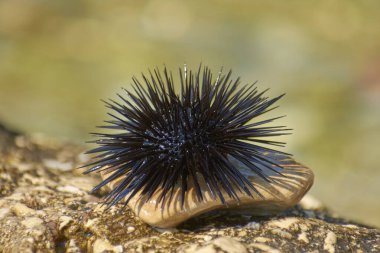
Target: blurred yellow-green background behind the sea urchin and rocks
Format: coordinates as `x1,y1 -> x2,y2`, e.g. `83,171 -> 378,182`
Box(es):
0,0 -> 380,226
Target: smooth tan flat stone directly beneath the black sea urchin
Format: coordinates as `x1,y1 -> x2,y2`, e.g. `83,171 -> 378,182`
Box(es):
100,155 -> 314,228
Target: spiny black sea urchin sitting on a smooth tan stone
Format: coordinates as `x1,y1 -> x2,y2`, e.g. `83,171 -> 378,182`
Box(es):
85,67 -> 288,210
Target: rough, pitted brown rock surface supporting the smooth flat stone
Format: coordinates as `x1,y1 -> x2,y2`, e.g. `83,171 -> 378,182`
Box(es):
0,121 -> 380,252
